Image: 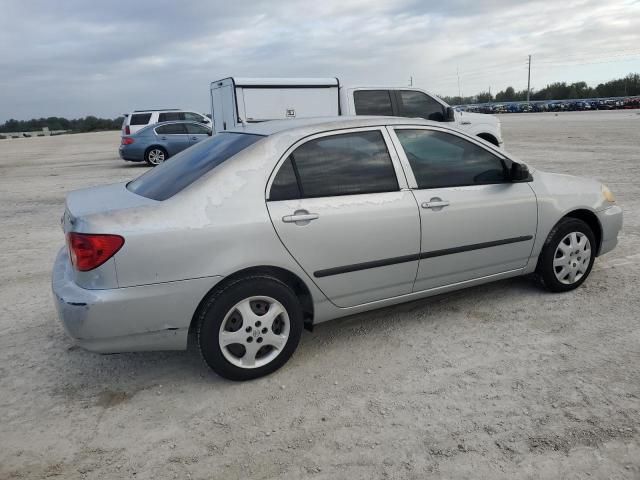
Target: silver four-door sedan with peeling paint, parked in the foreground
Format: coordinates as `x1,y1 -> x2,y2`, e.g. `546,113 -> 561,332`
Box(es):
53,117 -> 622,380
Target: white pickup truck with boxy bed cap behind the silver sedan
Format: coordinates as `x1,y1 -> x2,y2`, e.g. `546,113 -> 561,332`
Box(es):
210,77 -> 503,147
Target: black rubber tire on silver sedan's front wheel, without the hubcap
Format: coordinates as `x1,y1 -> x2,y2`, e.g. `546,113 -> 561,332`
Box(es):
536,217 -> 597,292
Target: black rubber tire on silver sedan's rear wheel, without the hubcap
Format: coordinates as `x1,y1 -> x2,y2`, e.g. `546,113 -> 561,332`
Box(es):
197,275 -> 303,381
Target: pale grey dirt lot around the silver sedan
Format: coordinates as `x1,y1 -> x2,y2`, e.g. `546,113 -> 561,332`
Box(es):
0,110 -> 640,480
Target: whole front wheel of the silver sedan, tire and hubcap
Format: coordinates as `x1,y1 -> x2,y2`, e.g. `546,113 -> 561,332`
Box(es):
536,218 -> 597,292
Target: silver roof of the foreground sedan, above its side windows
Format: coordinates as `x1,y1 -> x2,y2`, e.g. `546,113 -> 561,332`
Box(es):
227,115 -> 442,136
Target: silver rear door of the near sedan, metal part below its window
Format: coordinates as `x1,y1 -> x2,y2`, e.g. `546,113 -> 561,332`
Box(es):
267,190 -> 420,307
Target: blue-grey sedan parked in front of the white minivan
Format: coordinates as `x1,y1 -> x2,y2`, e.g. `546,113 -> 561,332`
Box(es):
119,122 -> 211,166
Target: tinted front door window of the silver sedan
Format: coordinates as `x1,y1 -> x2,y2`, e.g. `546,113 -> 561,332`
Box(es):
396,129 -> 508,188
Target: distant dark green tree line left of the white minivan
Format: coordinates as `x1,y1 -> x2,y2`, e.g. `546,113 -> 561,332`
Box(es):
0,115 -> 124,133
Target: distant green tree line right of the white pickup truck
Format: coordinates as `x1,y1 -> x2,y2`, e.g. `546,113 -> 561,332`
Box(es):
443,73 -> 640,105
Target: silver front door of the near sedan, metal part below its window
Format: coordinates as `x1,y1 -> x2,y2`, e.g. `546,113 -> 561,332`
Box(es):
414,183 -> 537,291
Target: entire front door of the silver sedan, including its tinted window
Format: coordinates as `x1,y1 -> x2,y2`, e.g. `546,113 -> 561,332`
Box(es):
392,127 -> 538,291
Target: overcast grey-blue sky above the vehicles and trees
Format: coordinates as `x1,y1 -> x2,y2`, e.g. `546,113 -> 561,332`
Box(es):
0,0 -> 640,122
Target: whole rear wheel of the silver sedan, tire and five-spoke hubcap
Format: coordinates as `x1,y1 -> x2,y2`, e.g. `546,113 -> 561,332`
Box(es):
198,276 -> 303,380
